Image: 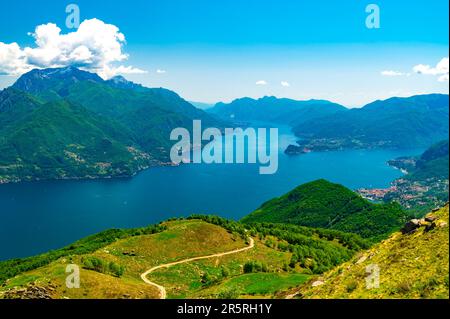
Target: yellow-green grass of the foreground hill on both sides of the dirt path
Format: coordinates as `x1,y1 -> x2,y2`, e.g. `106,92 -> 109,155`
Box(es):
0,218 -> 366,298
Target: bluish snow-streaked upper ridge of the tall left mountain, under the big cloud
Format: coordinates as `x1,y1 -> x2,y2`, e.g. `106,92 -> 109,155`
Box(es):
13,67 -> 223,125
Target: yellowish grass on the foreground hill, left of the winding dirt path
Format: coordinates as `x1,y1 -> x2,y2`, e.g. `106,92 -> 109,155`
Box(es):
0,220 -> 250,298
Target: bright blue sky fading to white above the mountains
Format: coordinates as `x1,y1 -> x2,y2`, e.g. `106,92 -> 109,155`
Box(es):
0,0 -> 449,107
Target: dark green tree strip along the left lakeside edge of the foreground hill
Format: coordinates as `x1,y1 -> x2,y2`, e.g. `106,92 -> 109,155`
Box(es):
0,225 -> 165,283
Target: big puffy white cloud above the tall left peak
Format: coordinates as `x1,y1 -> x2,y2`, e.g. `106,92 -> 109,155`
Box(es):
0,19 -> 145,78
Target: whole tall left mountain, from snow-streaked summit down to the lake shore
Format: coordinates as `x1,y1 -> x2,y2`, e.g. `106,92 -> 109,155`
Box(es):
0,67 -> 224,183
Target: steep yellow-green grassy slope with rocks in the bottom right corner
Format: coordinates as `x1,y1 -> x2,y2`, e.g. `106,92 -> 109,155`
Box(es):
290,205 -> 449,299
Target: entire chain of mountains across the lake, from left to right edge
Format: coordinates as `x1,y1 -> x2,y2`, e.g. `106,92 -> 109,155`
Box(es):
0,67 -> 449,183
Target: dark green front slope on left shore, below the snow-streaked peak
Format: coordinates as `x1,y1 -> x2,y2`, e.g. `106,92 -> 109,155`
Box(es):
0,100 -> 150,184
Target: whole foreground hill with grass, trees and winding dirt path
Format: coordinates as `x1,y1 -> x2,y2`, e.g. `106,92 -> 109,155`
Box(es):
0,216 -> 368,299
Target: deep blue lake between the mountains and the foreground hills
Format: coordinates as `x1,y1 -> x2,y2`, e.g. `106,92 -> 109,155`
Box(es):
0,127 -> 422,260
